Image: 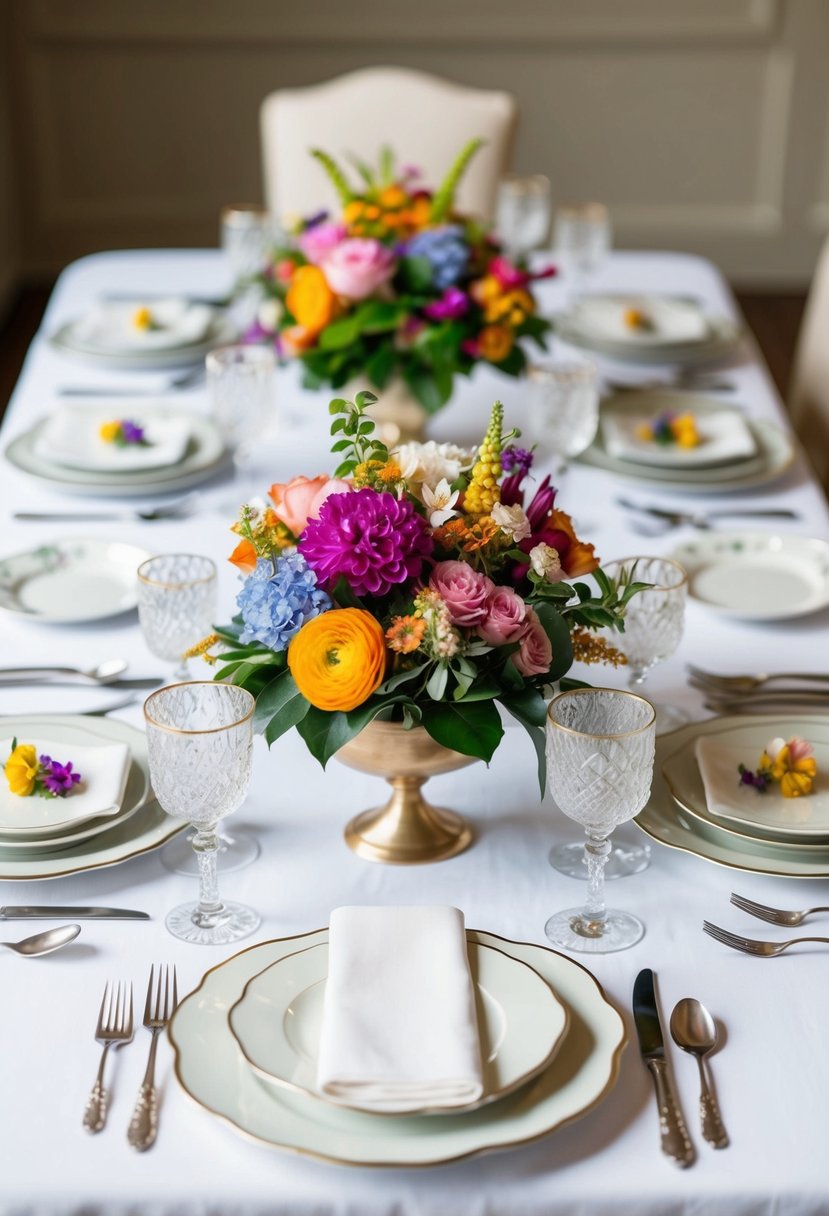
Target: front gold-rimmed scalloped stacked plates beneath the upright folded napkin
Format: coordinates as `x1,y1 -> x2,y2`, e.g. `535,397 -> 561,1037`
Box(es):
170,929 -> 626,1166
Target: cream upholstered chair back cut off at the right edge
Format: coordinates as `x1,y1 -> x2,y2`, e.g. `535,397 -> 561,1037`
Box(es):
789,238 -> 829,494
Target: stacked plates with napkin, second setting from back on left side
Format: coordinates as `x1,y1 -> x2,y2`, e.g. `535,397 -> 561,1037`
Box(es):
6,398 -> 225,497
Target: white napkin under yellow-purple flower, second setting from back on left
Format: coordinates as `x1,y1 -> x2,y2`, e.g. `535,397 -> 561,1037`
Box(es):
34,398 -> 192,473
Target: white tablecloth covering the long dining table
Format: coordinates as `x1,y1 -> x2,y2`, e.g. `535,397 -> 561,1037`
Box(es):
0,249 -> 829,1216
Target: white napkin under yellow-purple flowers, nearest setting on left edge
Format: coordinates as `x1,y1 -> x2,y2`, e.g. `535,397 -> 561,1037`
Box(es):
0,734 -> 130,835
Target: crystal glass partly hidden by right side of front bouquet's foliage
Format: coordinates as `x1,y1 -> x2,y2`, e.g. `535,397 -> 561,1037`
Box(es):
603,557 -> 688,734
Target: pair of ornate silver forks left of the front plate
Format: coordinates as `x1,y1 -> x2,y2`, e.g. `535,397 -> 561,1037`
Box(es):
84,966 -> 179,1153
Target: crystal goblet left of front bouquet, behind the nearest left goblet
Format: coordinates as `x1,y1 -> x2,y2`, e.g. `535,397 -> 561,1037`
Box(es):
137,553 -> 216,680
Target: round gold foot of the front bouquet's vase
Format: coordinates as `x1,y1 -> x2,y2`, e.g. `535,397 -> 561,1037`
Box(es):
344,801 -> 474,866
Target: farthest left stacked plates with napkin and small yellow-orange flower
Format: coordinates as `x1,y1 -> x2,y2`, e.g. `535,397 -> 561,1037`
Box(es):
51,298 -> 235,371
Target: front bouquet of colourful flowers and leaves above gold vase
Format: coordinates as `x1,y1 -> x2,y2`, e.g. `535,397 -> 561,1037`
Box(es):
194,393 -> 641,793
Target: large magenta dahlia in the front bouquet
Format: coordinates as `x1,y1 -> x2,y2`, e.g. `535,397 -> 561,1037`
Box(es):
299,489 -> 432,596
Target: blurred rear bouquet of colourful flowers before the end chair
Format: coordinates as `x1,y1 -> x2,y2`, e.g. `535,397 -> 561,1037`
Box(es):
248,140 -> 554,413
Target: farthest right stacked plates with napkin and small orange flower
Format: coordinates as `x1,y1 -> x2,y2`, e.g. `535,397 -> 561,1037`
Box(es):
556,295 -> 741,366
